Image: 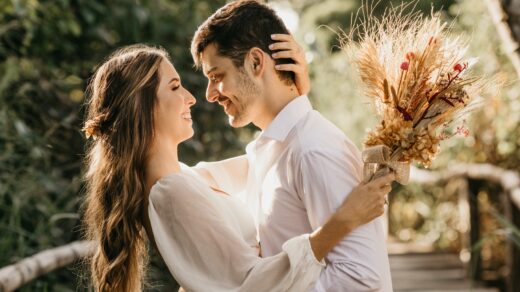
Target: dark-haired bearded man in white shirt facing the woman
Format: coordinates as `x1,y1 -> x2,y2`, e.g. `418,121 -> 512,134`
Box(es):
192,0 -> 392,291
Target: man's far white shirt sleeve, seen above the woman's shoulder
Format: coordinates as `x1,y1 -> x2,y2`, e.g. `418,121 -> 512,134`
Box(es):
192,155 -> 249,195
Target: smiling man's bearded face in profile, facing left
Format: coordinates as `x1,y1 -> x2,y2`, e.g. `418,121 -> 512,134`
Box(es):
202,44 -> 260,128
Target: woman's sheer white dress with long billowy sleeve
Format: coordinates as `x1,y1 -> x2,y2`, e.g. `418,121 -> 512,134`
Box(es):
148,166 -> 324,292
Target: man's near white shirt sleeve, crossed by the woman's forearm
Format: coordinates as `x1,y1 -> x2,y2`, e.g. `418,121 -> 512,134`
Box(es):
296,147 -> 387,291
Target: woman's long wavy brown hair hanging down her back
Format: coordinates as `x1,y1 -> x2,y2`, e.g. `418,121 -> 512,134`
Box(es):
84,45 -> 168,292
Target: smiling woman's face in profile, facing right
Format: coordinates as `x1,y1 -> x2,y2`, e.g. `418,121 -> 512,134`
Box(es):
154,59 -> 195,143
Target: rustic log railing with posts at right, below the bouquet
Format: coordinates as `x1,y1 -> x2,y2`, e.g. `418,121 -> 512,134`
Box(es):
411,164 -> 520,292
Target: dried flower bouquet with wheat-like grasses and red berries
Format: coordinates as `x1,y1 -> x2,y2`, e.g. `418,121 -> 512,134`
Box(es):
343,8 -> 490,184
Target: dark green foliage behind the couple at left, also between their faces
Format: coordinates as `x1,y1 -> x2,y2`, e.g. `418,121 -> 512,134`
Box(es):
0,0 -> 247,291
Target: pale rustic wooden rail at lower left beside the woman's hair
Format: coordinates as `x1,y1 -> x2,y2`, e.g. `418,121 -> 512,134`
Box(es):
0,241 -> 93,292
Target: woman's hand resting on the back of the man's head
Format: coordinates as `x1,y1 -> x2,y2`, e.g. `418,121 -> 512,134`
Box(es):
269,34 -> 311,95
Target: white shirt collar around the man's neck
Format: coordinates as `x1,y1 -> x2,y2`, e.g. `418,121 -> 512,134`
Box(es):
259,95 -> 312,141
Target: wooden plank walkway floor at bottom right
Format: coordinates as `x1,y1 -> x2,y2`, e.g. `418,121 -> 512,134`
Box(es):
390,253 -> 499,292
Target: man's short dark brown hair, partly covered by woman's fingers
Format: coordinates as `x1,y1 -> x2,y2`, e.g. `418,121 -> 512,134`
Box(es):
191,0 -> 295,83
